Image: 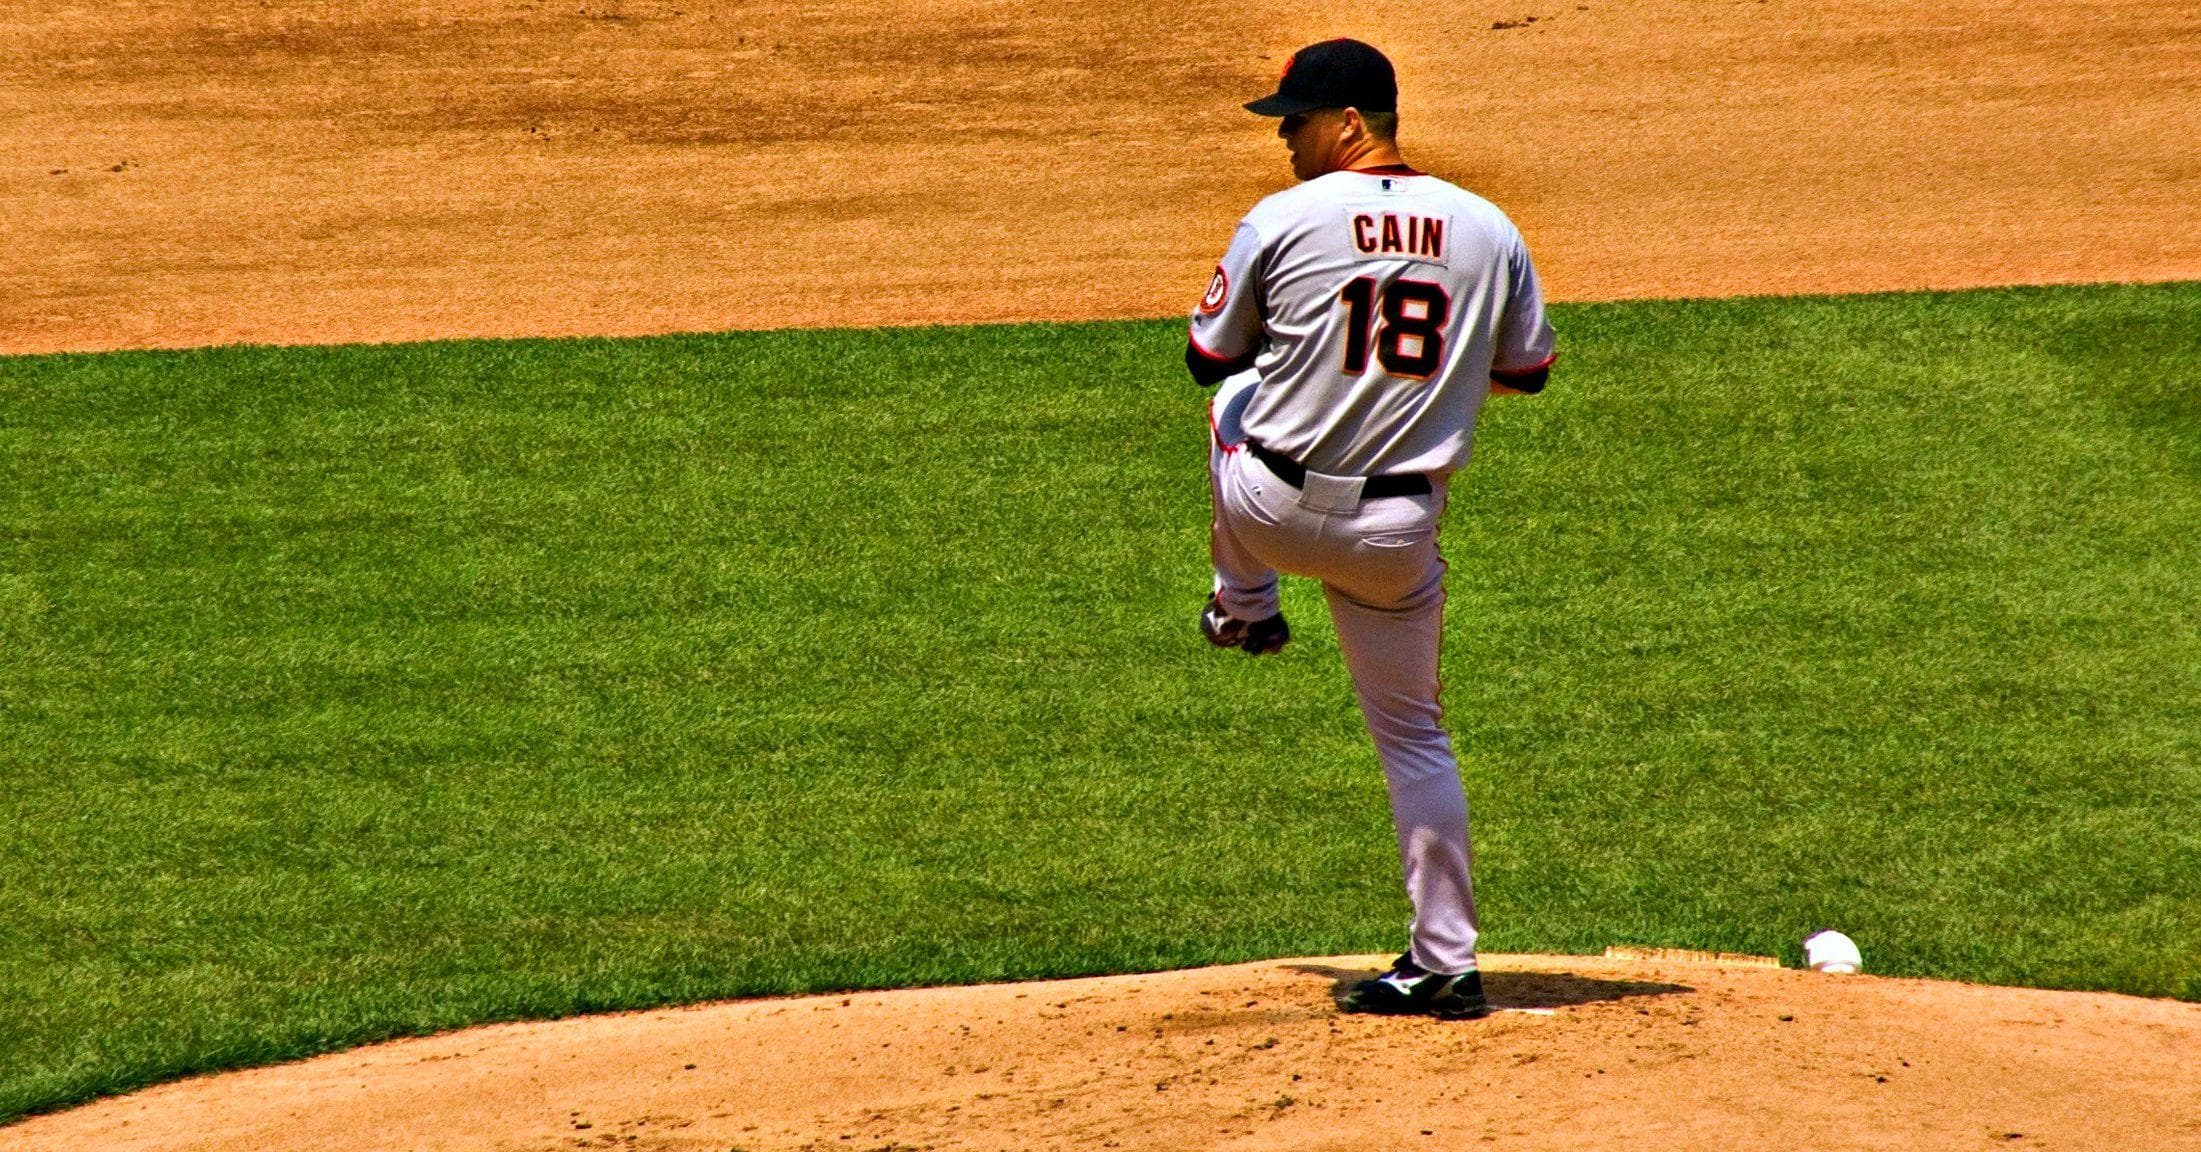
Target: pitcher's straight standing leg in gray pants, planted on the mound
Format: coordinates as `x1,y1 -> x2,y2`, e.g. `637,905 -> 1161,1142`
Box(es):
1323,500 -> 1479,974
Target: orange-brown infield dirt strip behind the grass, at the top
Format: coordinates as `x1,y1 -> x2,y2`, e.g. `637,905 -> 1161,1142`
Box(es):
0,0 -> 2201,352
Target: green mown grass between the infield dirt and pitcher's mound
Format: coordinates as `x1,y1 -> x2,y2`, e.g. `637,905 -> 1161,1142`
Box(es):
0,284 -> 2201,1117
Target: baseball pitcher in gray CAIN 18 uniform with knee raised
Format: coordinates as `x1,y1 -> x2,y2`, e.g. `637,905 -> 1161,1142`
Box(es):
1184,40 -> 1554,1020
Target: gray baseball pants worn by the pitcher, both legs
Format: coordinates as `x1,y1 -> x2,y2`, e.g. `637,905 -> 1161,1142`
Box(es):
1208,374 -> 1477,974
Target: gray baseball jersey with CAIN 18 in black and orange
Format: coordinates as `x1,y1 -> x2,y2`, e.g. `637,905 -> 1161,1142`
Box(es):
1191,167 -> 1552,476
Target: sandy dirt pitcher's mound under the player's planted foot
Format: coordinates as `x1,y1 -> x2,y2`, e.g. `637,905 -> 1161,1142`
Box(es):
0,956 -> 2201,1152
